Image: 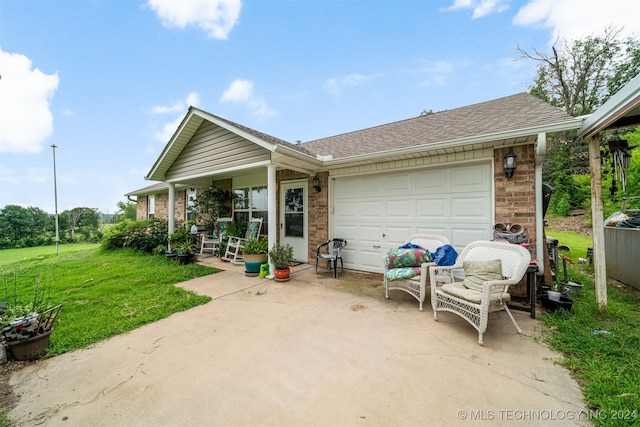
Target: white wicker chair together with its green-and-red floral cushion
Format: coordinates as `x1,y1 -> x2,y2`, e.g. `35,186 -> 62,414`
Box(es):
382,234 -> 450,311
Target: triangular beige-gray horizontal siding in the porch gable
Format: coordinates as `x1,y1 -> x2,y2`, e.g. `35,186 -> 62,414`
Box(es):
167,121 -> 270,179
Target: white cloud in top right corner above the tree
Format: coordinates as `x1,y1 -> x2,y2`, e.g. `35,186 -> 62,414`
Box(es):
513,0 -> 640,44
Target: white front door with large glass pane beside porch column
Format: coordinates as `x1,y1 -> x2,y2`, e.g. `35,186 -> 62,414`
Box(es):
280,180 -> 309,262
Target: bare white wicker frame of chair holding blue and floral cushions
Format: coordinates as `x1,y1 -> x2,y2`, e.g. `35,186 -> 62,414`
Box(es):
382,234 -> 450,311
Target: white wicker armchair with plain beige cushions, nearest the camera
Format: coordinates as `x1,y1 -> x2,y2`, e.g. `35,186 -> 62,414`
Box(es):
429,241 -> 531,345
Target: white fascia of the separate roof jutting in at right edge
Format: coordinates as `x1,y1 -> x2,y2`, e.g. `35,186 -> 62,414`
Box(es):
578,74 -> 640,138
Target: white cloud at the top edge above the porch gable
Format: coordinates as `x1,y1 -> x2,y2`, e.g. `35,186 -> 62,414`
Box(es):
147,0 -> 242,39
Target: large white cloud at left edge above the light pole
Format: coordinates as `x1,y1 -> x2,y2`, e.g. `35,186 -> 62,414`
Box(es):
0,48 -> 59,153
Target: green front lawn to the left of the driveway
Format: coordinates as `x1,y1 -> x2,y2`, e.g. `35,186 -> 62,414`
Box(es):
0,247 -> 216,355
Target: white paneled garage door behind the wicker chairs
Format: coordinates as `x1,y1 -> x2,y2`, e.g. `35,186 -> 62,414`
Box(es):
331,163 -> 493,272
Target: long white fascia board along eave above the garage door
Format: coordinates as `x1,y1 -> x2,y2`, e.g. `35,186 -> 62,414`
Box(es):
323,117 -> 583,167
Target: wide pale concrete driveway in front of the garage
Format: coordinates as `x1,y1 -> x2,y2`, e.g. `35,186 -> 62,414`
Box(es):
9,261 -> 589,426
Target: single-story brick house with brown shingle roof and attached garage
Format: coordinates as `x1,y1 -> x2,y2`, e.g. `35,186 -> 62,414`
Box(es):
127,93 -> 583,272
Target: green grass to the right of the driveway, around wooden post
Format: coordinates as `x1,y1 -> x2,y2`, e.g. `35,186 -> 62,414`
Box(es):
540,232 -> 640,426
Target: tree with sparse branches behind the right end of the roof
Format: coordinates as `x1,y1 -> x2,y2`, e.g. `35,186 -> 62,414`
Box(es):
517,27 -> 640,214
